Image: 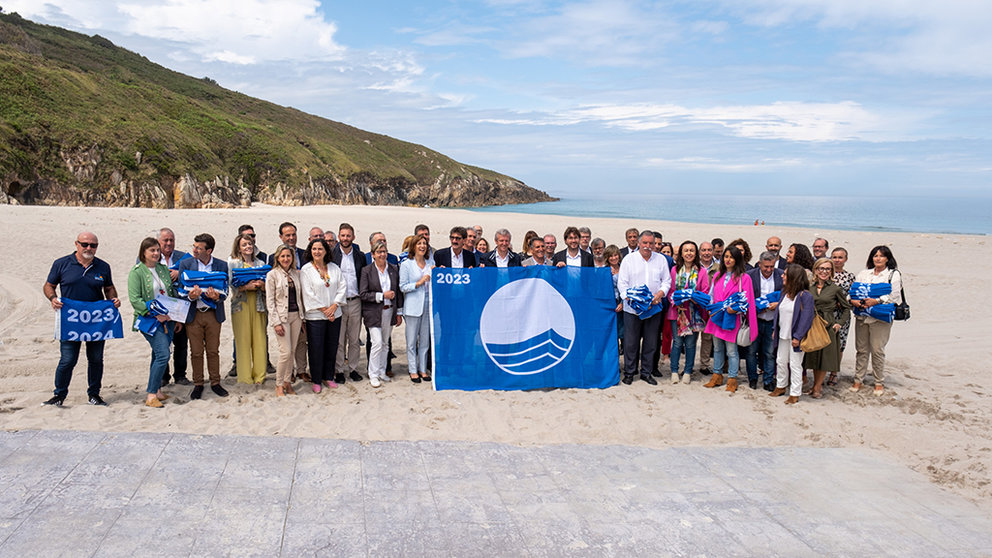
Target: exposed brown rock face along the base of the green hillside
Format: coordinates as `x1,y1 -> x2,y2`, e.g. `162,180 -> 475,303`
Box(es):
0,146 -> 553,208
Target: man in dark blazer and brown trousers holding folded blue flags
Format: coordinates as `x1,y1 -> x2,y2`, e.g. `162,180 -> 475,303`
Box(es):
179,233 -> 227,399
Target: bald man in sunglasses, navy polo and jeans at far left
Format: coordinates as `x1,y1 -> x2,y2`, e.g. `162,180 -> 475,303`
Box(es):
42,232 -> 121,407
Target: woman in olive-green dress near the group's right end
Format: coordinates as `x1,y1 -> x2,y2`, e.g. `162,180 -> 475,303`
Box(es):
803,258 -> 851,399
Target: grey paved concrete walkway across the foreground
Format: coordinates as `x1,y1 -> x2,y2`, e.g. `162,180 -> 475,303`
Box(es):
0,431 -> 992,558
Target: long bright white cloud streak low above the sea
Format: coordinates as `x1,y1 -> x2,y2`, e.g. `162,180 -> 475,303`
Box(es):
480,101 -> 907,142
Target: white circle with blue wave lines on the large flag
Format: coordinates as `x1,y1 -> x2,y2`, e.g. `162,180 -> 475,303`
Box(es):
479,278 -> 575,375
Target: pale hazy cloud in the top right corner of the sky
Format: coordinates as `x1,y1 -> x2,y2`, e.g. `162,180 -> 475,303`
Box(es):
727,0 -> 992,76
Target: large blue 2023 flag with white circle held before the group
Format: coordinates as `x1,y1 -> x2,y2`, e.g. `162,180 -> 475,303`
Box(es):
431,265 -> 620,390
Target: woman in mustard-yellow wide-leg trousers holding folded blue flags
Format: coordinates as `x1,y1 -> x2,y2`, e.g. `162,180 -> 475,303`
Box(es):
227,234 -> 268,384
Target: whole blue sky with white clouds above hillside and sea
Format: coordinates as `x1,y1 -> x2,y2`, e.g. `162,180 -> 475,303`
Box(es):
9,0 -> 992,201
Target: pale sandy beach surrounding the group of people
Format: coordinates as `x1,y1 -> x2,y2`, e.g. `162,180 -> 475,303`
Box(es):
0,205 -> 992,511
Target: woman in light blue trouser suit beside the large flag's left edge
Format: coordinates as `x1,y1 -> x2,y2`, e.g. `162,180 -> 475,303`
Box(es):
400,234 -> 434,384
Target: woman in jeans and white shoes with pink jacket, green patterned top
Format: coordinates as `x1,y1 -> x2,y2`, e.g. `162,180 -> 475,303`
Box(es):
665,240 -> 709,384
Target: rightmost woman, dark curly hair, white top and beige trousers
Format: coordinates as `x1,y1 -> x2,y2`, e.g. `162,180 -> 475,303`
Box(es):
851,245 -> 902,395
